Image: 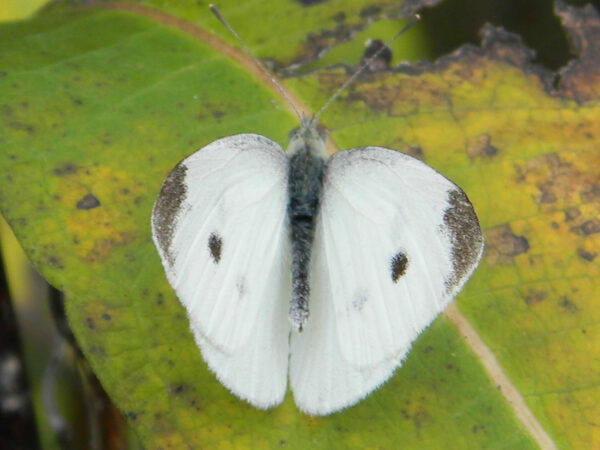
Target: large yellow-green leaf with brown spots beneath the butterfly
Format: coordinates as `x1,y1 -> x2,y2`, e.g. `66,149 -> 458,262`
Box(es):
0,2 -> 600,448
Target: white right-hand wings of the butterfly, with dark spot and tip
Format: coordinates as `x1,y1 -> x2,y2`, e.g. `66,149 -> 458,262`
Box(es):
290,147 -> 483,414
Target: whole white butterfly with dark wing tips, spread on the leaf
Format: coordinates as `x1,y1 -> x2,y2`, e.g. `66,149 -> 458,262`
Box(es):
152,7 -> 483,415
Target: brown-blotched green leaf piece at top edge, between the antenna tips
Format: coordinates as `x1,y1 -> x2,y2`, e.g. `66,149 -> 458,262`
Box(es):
132,0 -> 432,68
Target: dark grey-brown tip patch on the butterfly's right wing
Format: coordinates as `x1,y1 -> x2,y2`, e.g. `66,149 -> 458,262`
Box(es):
444,189 -> 483,291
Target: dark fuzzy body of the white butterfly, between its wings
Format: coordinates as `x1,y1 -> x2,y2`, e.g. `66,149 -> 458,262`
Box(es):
287,122 -> 326,331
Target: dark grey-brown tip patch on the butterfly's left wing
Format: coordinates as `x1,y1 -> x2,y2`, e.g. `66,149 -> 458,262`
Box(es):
152,162 -> 187,265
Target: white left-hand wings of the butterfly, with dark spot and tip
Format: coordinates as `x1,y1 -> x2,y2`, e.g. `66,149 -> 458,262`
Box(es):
152,134 -> 290,407
